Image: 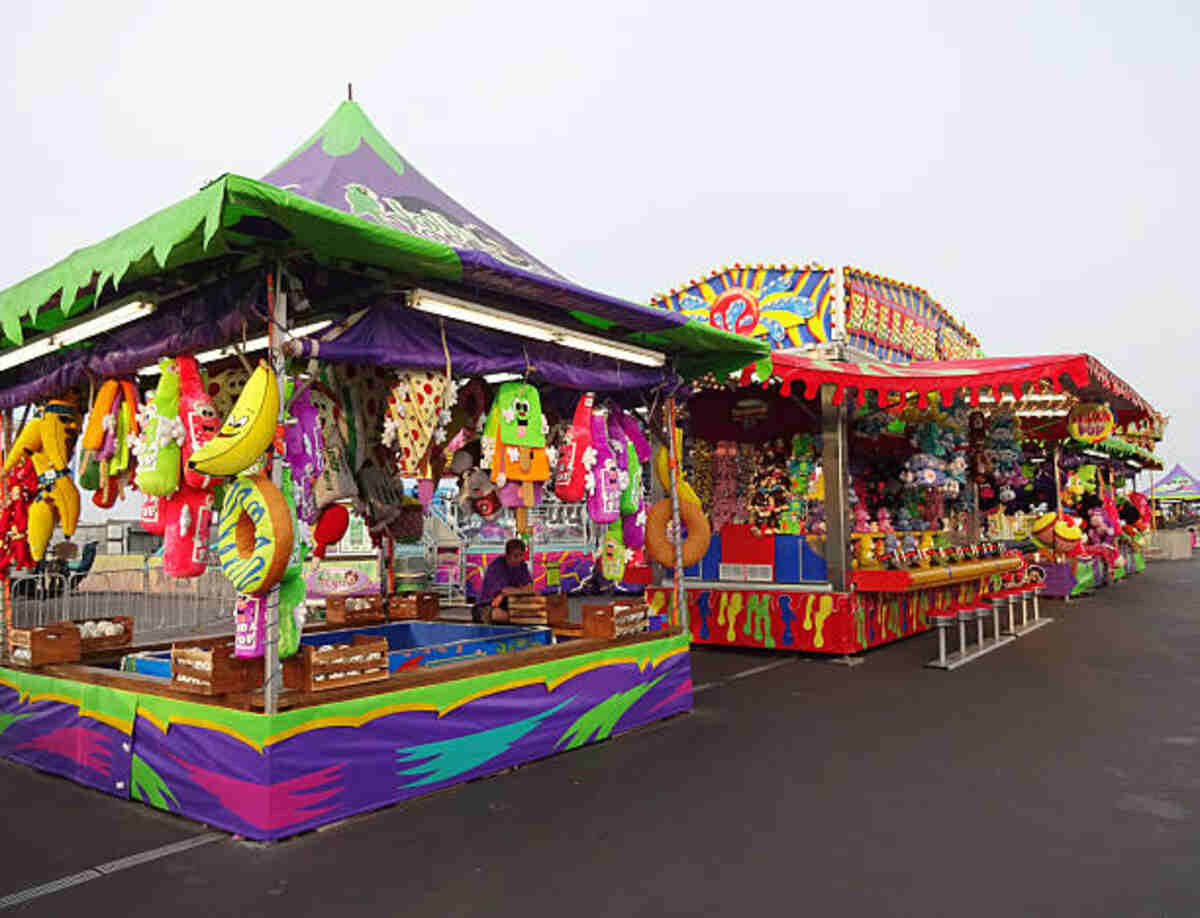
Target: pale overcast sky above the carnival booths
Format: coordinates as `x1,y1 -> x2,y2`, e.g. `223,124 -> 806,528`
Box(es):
0,0 -> 1200,518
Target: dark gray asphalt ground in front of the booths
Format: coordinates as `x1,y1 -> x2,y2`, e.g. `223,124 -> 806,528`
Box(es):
0,562 -> 1200,918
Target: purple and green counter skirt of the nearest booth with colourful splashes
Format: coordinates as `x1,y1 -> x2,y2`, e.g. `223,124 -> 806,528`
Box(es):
0,631 -> 691,840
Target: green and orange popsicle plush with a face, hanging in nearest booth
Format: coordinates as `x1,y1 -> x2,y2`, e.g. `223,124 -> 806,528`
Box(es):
484,382 -> 550,506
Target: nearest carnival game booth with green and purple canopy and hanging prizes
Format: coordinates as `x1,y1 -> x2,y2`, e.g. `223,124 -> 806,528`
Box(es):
0,103 -> 766,839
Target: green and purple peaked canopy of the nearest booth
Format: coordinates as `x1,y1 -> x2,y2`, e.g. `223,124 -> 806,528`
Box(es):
0,102 -> 768,386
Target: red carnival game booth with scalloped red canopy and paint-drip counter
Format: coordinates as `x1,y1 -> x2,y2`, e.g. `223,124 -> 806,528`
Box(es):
648,353 -> 1151,654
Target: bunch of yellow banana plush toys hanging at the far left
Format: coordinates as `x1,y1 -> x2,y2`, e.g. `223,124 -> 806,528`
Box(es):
5,394 -> 80,562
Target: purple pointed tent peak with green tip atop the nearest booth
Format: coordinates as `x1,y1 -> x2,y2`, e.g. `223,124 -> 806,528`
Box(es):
263,101 -> 564,280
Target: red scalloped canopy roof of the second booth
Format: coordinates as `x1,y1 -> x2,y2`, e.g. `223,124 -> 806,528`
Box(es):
742,354 -> 1154,424
